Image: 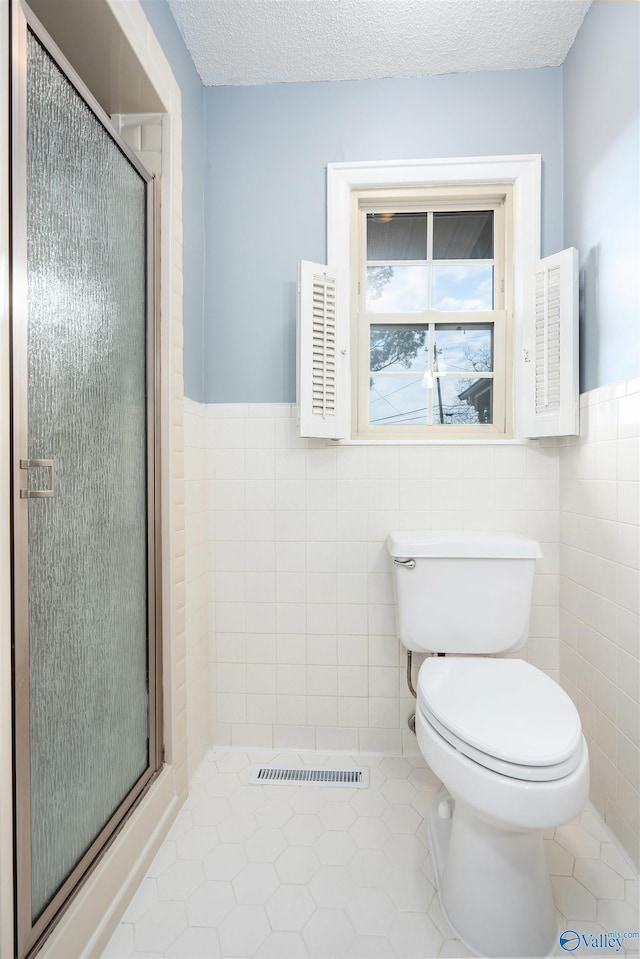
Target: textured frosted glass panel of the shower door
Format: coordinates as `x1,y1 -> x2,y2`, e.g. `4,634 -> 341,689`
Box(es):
28,35 -> 148,919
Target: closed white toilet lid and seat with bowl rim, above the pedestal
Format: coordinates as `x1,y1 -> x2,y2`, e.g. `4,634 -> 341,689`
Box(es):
416,656 -> 587,830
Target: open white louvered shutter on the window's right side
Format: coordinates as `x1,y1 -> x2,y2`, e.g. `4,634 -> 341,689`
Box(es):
523,248 -> 580,437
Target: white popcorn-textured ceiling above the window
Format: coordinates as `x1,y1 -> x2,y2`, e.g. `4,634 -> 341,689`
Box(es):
169,0 -> 590,86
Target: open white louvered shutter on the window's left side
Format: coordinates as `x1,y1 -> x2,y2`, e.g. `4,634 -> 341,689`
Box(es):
297,260 -> 348,439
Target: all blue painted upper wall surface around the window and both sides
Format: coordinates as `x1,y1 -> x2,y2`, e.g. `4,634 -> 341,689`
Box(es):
142,0 -> 640,402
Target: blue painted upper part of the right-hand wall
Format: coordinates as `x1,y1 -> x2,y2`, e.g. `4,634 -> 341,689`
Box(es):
563,2 -> 640,391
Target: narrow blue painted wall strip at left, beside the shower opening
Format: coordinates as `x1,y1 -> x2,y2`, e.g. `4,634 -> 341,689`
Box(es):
141,0 -> 205,401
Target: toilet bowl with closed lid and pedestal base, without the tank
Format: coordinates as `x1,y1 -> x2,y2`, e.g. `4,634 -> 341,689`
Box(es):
416,657 -> 589,957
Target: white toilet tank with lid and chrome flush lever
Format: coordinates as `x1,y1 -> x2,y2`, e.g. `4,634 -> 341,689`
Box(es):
387,530 -> 542,654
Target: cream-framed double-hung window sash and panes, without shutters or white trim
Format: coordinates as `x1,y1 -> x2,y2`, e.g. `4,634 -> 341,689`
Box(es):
351,187 -> 510,440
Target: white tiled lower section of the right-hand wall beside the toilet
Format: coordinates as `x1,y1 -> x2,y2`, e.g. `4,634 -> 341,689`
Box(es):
560,380 -> 640,862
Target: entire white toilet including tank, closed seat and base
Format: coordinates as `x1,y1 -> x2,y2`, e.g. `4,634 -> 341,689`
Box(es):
387,531 -> 589,957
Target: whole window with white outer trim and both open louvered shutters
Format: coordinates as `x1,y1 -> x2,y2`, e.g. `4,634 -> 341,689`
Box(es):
298,155 -> 579,443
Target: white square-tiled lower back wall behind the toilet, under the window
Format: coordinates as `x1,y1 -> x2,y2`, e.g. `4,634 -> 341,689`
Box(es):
186,403 -> 559,753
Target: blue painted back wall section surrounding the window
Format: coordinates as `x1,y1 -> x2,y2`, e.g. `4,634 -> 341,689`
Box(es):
205,68 -> 562,403
